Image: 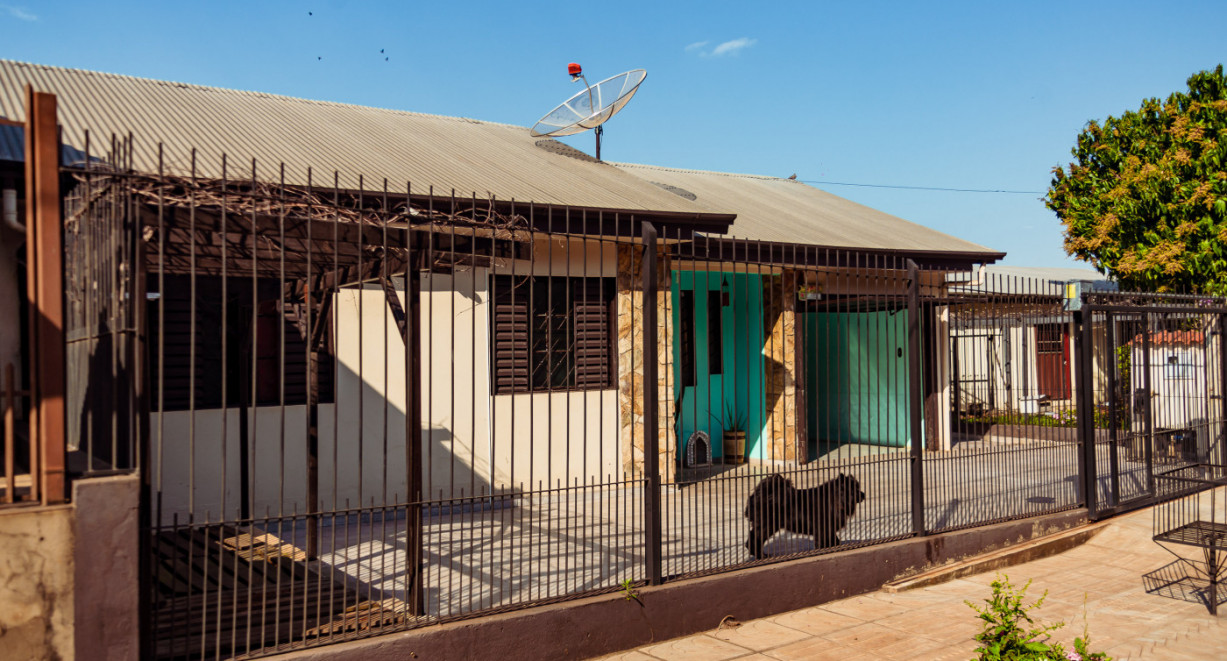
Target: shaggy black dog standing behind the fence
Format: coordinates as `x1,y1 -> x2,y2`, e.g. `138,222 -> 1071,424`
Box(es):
746,473 -> 865,558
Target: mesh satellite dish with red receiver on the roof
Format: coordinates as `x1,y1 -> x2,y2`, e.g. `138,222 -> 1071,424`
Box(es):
531,63 -> 648,161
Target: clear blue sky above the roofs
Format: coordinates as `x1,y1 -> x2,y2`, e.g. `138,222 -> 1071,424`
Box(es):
0,0 -> 1227,266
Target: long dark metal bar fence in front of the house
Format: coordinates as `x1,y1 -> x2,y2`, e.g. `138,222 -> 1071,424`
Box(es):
43,131 -> 1227,659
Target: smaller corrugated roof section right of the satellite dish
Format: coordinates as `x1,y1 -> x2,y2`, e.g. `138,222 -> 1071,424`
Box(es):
617,163 -> 1000,256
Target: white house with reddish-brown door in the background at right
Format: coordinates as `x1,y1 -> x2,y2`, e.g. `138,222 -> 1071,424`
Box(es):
951,265 -> 1117,416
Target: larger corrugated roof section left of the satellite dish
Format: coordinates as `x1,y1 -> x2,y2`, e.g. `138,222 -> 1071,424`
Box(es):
0,60 -> 719,213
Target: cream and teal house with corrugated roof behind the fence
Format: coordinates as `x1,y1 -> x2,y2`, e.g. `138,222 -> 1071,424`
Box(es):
0,61 -> 1002,520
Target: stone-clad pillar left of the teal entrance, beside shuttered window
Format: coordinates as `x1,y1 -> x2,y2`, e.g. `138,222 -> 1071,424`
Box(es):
617,245 -> 677,482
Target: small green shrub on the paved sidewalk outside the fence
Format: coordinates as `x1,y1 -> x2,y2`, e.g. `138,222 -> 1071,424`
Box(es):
966,574 -> 1112,661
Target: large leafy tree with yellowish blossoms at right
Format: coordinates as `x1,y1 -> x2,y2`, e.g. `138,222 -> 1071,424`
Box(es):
1045,65 -> 1227,296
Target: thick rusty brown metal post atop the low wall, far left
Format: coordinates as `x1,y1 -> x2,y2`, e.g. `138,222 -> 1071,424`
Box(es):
26,85 -> 67,503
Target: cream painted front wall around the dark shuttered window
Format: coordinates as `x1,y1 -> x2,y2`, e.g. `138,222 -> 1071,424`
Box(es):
151,239 -> 621,522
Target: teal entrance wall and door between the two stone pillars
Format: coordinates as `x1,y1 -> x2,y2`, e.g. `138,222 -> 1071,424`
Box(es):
671,271 -> 764,460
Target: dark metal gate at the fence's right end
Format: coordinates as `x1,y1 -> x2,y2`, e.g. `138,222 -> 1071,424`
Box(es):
1077,294 -> 1227,516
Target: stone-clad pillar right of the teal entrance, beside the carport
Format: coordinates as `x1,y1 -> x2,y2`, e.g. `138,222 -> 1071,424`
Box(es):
762,271 -> 805,462
